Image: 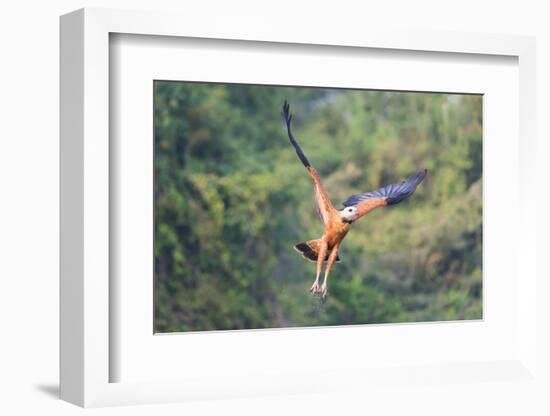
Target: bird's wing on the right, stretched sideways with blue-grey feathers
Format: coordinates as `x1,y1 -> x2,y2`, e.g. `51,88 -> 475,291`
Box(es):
342,169 -> 428,221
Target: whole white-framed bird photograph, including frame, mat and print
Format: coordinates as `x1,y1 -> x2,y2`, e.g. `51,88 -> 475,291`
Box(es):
61,9 -> 536,406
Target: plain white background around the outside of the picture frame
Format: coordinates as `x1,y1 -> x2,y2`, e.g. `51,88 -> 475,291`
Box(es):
0,0 -> 550,415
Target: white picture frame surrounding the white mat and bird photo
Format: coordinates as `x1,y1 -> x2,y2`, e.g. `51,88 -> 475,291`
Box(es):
60,9 -> 537,406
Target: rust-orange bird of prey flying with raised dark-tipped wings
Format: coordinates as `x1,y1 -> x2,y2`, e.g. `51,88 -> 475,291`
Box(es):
283,101 -> 428,300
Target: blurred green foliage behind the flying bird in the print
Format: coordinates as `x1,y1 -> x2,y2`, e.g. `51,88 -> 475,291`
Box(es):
154,81 -> 482,332
